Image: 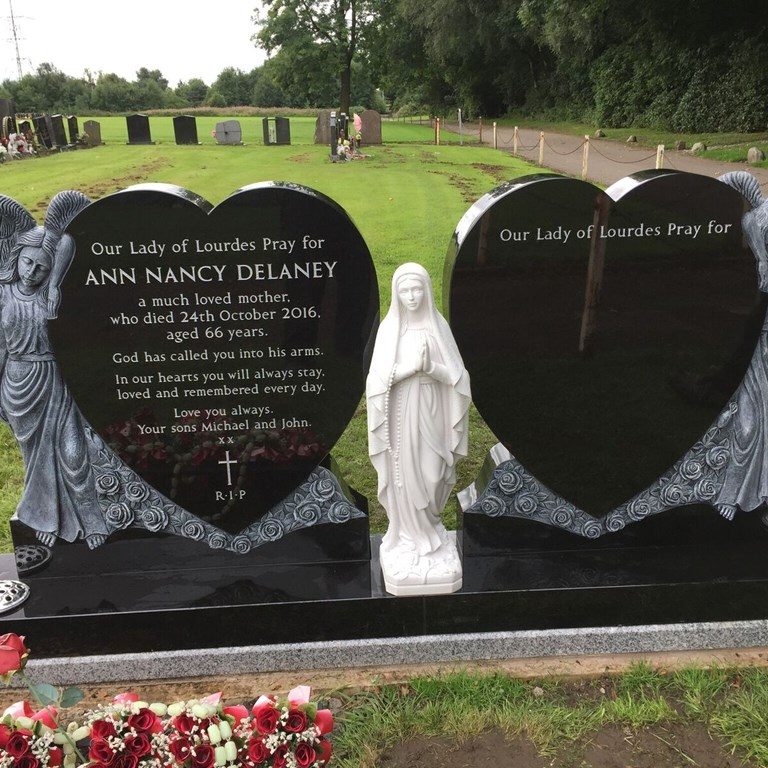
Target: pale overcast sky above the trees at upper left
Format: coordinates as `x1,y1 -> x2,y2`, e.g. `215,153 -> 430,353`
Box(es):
0,0 -> 266,87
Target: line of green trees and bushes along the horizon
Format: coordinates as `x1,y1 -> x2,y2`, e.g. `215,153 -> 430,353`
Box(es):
0,0 -> 768,131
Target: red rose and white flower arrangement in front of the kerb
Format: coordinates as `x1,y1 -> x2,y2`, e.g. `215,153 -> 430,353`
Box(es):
0,634 -> 333,768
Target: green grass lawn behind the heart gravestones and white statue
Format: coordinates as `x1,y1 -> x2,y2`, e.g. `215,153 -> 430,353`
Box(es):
0,127 -> 532,550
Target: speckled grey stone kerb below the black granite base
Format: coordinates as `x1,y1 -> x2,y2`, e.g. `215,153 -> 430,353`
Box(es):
21,620 -> 768,685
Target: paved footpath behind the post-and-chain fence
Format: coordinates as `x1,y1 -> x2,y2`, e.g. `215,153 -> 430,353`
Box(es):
445,123 -> 768,194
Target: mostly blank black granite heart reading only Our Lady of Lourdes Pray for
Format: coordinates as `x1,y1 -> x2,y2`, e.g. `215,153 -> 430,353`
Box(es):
444,172 -> 764,516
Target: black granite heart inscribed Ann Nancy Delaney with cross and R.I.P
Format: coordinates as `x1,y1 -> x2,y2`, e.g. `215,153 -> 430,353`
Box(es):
50,183 -> 378,533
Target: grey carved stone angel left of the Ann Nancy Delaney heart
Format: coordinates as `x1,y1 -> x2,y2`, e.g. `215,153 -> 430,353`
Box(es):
0,191 -> 108,548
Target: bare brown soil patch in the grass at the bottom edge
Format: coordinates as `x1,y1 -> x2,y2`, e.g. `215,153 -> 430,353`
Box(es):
381,723 -> 759,768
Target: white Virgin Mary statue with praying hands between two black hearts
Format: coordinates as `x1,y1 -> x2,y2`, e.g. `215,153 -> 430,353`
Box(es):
366,263 -> 471,595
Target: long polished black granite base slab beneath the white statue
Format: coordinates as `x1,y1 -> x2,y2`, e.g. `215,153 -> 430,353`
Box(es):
0,537 -> 768,657
